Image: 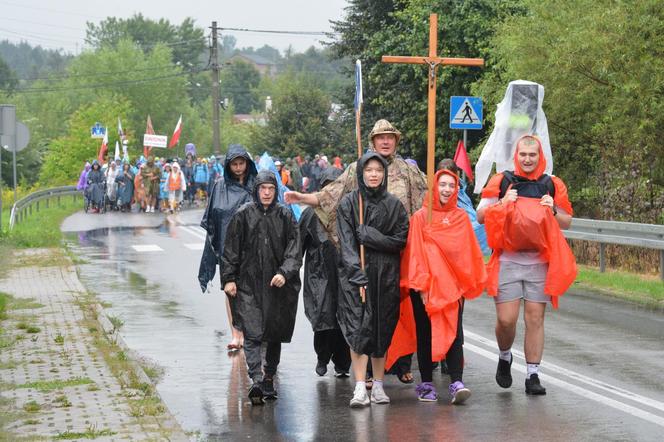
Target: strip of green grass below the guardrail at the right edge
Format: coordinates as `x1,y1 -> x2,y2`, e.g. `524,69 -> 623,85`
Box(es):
576,265 -> 664,305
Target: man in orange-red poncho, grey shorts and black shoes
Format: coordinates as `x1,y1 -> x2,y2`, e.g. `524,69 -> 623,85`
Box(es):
477,135 -> 576,395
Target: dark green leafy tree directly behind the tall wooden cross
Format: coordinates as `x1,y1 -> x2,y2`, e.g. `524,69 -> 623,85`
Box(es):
331,0 -> 523,163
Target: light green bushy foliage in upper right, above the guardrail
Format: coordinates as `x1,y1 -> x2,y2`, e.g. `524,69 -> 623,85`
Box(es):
475,0 -> 664,223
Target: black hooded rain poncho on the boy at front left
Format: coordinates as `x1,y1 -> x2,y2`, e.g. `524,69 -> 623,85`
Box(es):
221,170 -> 302,342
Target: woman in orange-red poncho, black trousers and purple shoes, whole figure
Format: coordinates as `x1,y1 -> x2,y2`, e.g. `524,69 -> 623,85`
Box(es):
388,169 -> 486,404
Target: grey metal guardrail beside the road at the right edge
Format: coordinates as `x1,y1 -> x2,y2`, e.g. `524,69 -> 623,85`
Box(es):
563,218 -> 664,281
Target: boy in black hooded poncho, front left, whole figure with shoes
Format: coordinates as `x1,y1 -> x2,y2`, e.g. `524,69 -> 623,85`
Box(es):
221,170 -> 302,405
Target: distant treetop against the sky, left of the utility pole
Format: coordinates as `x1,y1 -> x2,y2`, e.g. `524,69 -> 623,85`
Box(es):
85,13 -> 206,66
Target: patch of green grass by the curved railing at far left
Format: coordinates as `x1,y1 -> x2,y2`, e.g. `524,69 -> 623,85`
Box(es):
0,196 -> 83,248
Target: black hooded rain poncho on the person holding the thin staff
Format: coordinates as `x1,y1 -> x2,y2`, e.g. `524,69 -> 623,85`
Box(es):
337,152 -> 408,357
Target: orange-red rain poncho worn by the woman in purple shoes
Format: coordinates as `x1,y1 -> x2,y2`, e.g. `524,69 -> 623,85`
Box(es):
386,170 -> 487,367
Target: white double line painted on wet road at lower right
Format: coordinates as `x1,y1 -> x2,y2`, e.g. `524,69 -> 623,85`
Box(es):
464,329 -> 664,427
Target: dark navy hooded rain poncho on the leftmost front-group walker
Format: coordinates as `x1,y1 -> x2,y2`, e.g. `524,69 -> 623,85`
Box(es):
198,144 -> 256,291
